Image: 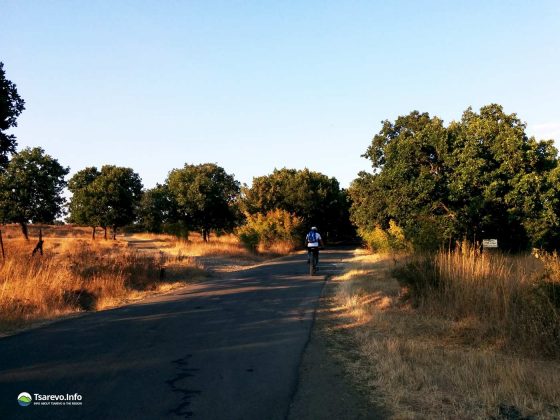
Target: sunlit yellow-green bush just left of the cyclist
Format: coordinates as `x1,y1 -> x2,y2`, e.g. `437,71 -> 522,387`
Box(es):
236,209 -> 303,252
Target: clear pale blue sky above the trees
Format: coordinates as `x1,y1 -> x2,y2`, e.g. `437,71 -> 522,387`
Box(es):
0,0 -> 560,187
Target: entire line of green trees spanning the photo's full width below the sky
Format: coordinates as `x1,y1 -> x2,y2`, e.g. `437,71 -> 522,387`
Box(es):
0,63 -> 560,250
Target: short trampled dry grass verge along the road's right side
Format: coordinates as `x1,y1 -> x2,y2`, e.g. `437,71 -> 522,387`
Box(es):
333,254 -> 560,419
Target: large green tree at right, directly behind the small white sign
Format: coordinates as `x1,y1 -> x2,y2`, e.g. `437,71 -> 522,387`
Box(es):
448,104 -> 557,249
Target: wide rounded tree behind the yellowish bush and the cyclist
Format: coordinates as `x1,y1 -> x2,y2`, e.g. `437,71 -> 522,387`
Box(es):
242,168 -> 353,238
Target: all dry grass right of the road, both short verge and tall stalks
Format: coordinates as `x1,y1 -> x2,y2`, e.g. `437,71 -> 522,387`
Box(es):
330,251 -> 560,419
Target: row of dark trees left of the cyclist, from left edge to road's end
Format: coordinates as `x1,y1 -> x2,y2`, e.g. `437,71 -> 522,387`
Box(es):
0,63 -> 353,242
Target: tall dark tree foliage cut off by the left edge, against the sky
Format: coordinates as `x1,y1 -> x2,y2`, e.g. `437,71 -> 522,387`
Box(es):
0,62 -> 25,169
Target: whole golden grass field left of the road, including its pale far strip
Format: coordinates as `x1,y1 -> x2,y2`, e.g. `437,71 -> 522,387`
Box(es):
0,225 -> 263,333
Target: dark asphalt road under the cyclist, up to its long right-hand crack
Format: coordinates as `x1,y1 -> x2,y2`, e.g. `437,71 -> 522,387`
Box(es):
0,250 -> 350,420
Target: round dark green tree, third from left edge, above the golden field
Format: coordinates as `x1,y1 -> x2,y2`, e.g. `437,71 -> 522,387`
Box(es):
69,165 -> 142,239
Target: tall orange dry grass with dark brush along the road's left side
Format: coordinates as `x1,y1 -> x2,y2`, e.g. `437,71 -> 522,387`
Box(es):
0,238 -> 205,331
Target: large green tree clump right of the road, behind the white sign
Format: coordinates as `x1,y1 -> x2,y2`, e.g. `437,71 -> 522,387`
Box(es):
350,104 -> 560,249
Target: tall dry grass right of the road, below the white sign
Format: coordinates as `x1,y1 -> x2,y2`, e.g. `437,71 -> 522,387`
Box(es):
394,247 -> 560,357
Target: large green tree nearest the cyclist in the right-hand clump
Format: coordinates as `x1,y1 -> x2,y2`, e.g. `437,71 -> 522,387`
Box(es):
350,111 -> 454,247
